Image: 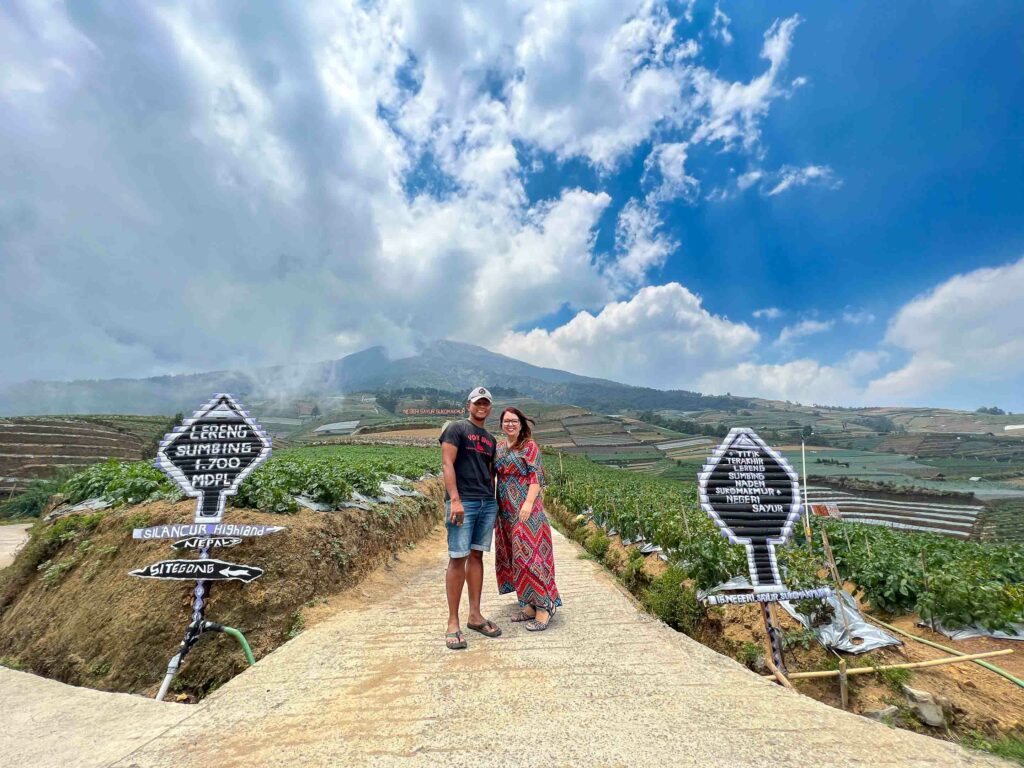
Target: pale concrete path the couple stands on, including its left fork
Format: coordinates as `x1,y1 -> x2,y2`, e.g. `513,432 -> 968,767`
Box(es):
0,530 -> 1005,768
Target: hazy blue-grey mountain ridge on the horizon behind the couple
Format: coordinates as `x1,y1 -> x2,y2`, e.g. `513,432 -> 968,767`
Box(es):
0,341 -> 746,416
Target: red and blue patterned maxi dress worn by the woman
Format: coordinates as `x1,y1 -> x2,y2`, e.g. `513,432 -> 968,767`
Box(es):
495,440 -> 562,610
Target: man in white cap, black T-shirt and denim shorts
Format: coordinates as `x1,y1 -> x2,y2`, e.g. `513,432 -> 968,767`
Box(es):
440,387 -> 502,650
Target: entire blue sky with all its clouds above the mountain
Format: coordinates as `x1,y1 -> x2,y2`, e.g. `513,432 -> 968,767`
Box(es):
0,0 -> 1024,411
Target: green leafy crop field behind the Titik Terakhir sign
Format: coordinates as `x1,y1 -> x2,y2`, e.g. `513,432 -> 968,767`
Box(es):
547,456 -> 1024,630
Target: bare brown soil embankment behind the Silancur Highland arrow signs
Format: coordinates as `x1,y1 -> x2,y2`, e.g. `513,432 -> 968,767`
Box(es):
0,480 -> 441,700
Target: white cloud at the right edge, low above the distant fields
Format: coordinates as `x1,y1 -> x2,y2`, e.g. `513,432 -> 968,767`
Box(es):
867,258 -> 1024,403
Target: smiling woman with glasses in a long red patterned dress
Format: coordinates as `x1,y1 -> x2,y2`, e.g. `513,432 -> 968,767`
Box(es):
495,408 -> 562,632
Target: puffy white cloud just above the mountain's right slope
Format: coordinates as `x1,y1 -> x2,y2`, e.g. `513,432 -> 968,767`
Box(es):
499,283 -> 760,388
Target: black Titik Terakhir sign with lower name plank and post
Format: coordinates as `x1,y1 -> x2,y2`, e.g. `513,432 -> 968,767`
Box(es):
697,427 -> 829,672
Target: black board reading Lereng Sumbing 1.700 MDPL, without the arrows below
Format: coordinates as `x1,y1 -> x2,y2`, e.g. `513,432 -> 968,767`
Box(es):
156,394 -> 270,523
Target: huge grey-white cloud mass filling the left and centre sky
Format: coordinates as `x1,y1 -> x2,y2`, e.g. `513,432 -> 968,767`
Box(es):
0,0 -> 815,384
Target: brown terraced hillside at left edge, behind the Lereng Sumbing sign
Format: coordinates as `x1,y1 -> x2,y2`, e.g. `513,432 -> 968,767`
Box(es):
0,416 -> 171,499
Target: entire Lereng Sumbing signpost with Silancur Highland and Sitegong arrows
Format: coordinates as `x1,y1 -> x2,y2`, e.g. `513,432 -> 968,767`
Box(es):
131,394 -> 284,699
